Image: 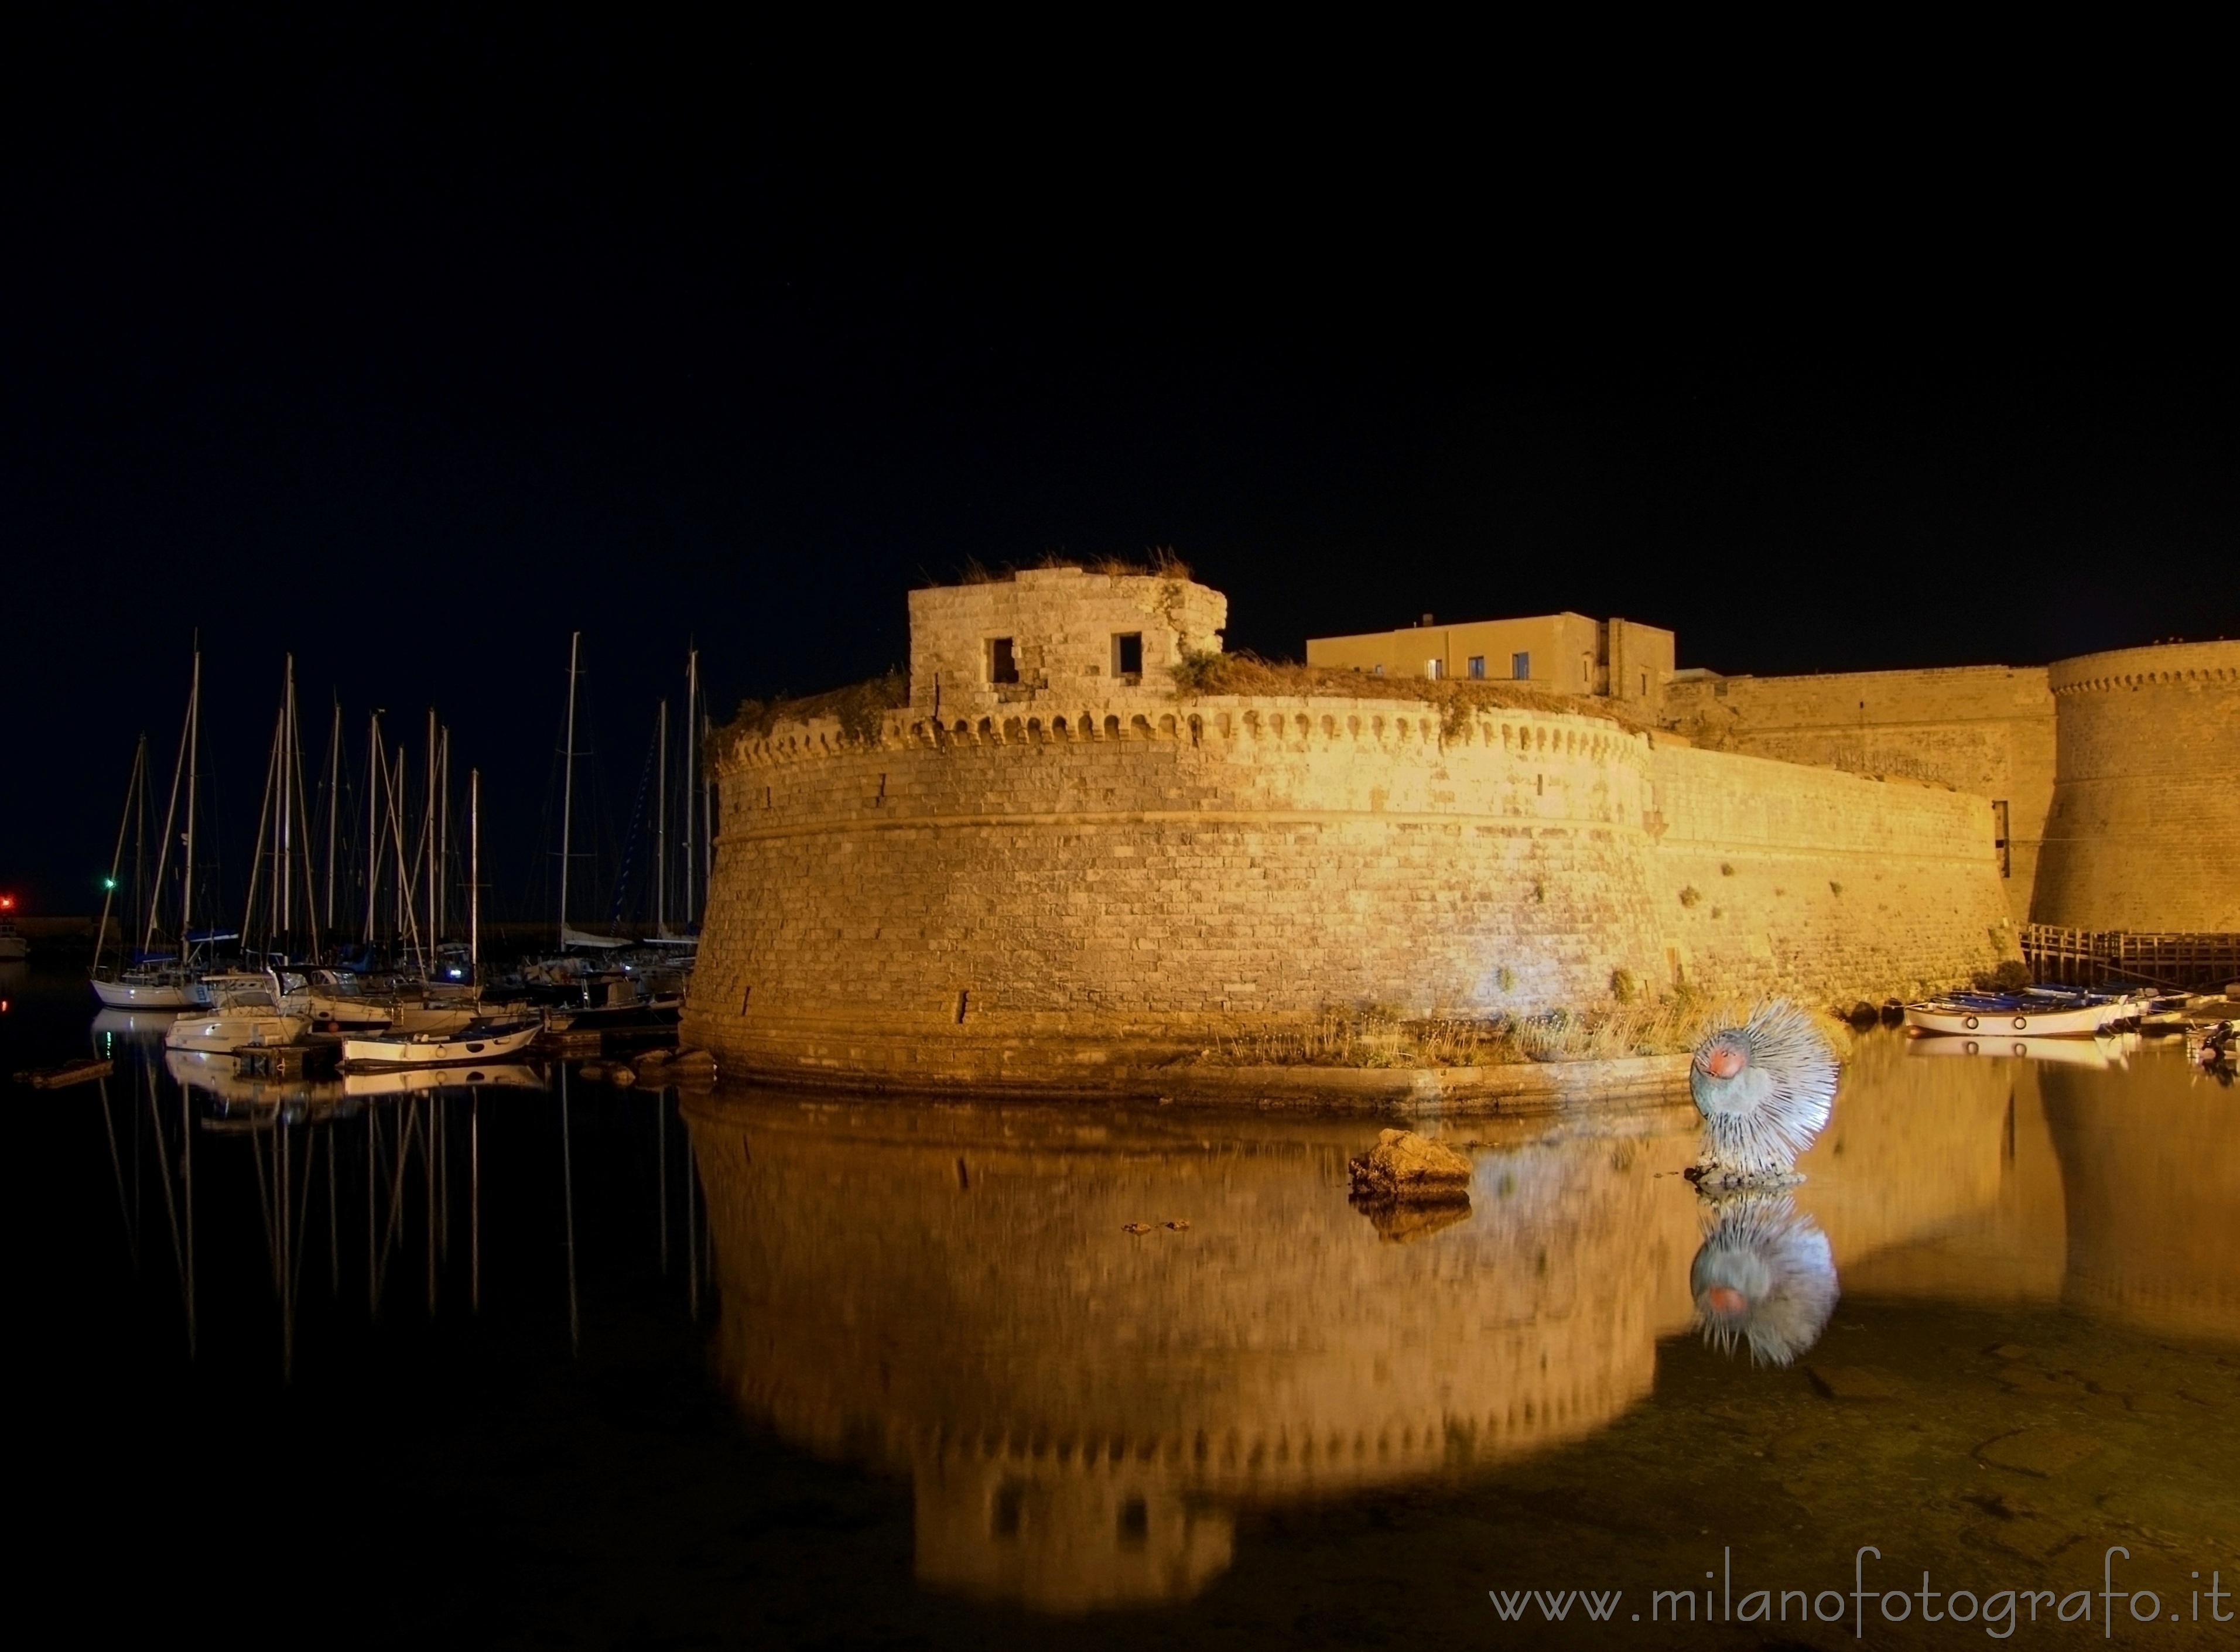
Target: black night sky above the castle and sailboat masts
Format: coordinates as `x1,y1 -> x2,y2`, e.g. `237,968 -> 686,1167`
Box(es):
0,6 -> 2240,911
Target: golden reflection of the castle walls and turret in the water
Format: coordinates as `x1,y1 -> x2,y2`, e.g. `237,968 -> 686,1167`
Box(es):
690,1041 -> 2240,1612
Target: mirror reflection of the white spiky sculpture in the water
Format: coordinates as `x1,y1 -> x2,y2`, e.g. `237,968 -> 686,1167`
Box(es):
1687,1193 -> 1837,1366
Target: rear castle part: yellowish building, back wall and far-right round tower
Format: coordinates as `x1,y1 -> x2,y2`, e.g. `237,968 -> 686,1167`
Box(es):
1306,613 -> 2240,936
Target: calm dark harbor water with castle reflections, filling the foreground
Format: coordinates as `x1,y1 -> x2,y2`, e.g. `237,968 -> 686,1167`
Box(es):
0,972 -> 2240,1647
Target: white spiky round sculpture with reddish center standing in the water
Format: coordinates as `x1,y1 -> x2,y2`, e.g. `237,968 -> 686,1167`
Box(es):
1687,998 -> 1837,1182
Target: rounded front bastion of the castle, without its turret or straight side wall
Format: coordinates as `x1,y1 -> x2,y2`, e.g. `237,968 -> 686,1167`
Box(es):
688,696 -> 1658,1088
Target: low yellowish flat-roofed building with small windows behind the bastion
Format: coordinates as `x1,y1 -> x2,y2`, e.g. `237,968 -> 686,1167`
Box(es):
1306,613 -> 1673,712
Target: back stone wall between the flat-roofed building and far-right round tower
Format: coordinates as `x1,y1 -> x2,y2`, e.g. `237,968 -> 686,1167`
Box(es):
1664,665 -> 2054,925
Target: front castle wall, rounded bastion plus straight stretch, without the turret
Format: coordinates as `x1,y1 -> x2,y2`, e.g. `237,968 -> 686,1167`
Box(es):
685,694 -> 2012,1090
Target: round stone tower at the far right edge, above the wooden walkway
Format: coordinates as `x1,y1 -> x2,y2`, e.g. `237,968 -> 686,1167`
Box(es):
2034,642 -> 2240,933
